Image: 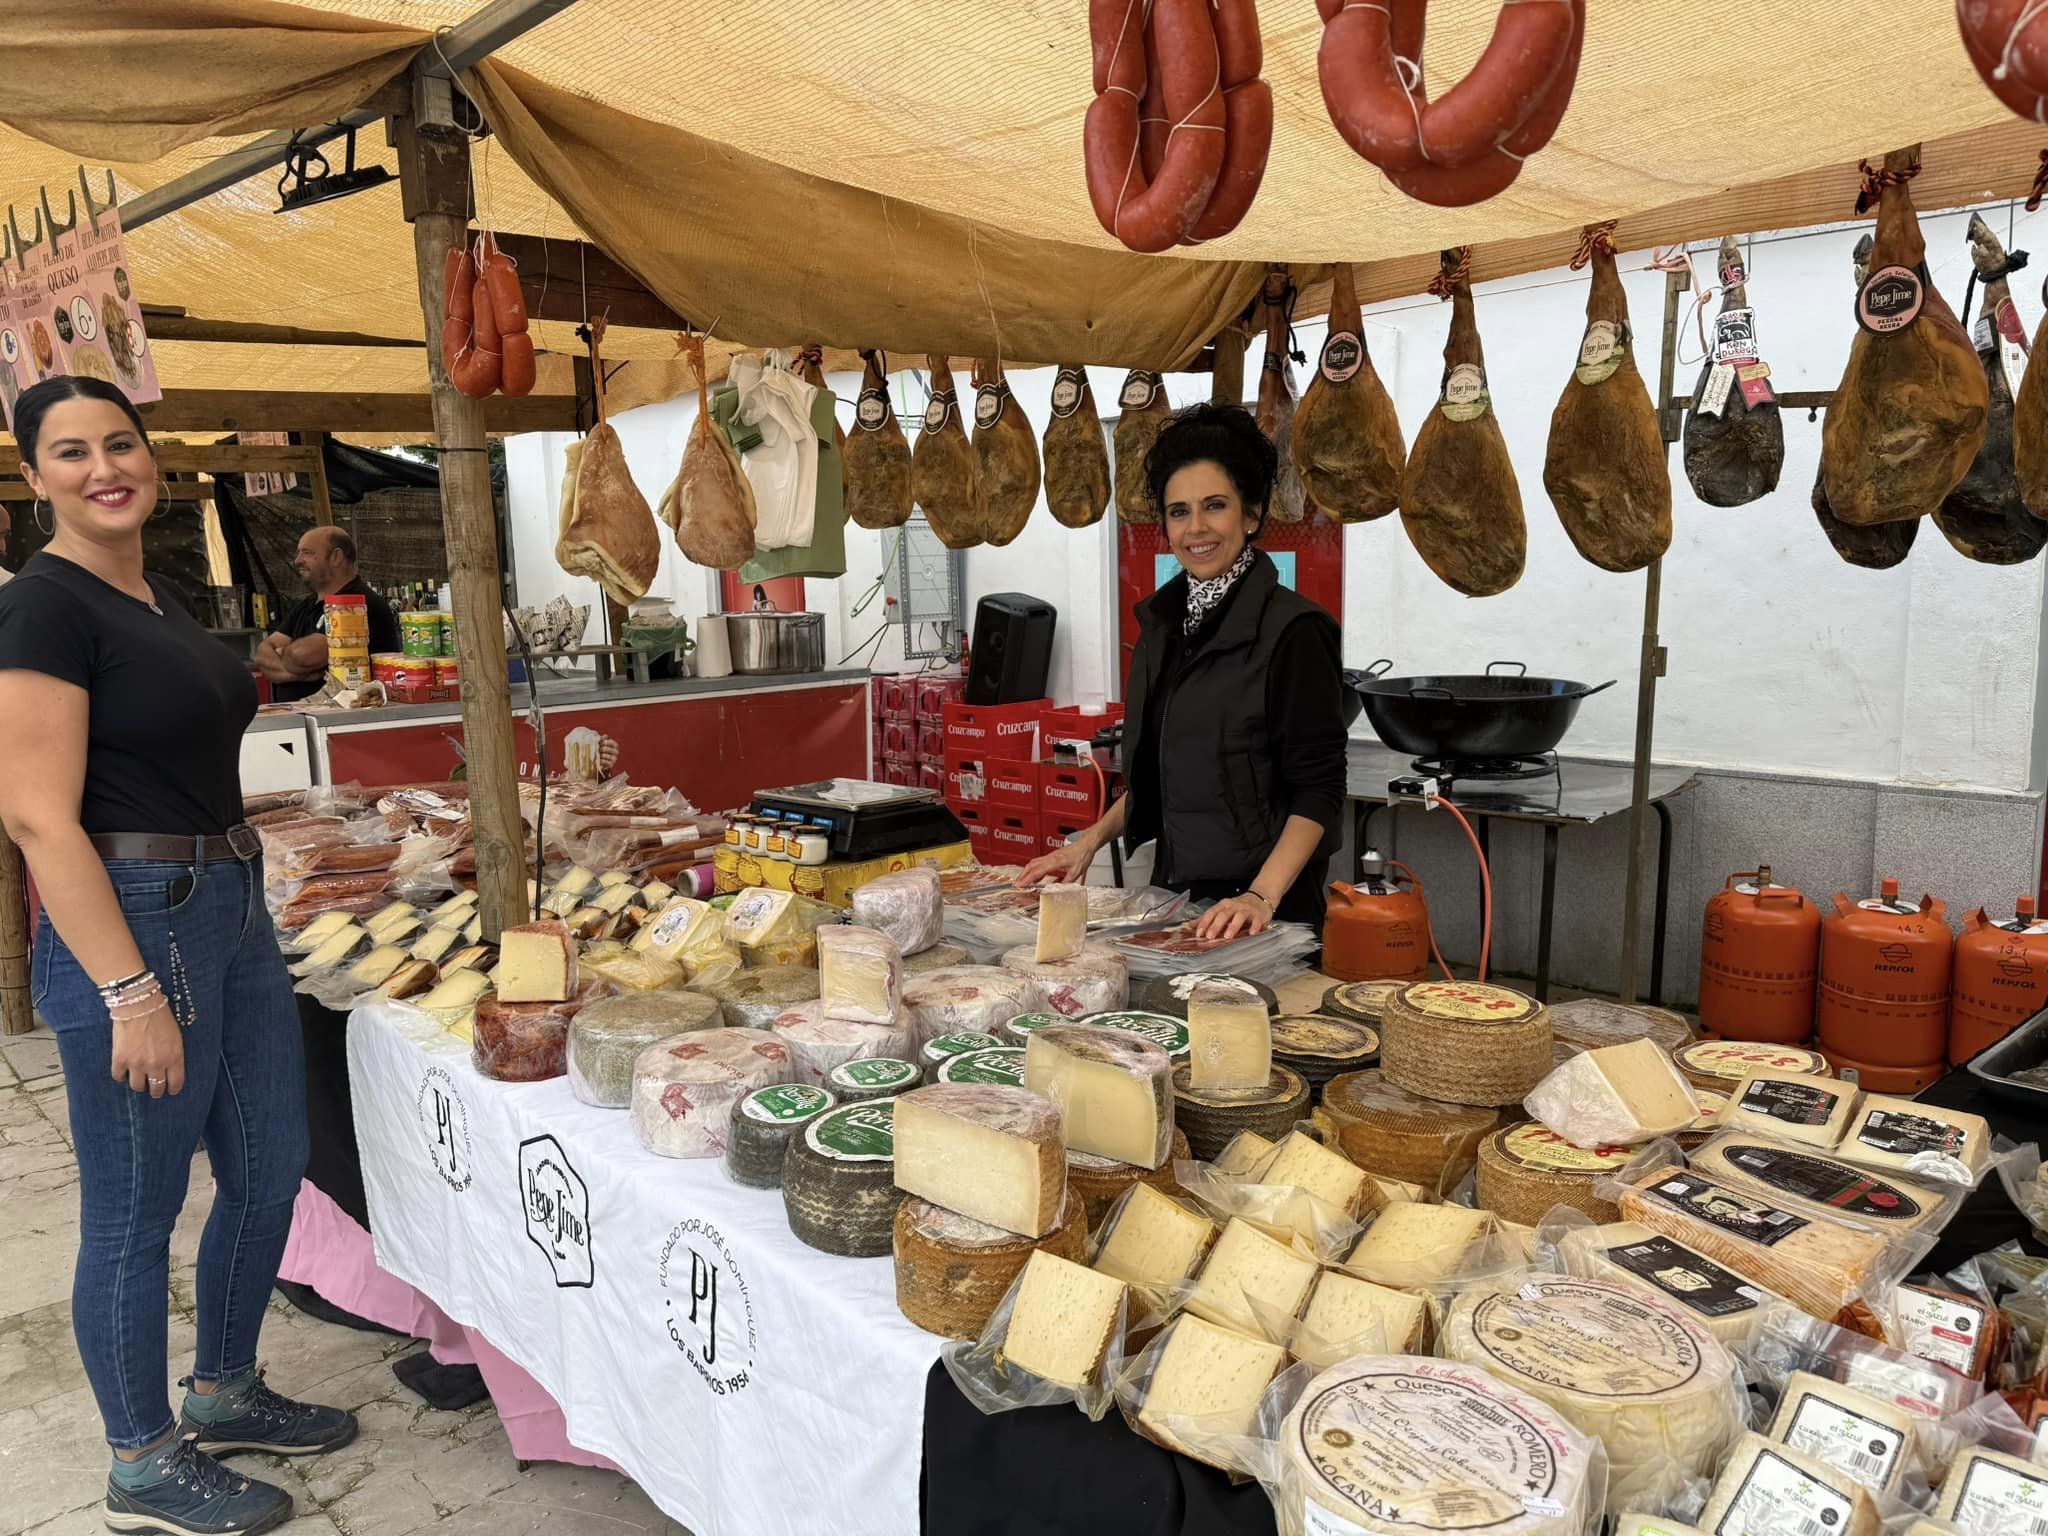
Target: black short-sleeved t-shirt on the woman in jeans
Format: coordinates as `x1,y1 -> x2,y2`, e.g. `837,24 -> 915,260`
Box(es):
0,553 -> 256,838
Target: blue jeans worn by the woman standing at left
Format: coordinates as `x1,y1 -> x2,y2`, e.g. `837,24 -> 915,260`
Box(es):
31,860 -> 305,1450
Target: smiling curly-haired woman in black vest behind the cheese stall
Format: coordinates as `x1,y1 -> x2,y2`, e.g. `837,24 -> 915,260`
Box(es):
1020,406 -> 1346,938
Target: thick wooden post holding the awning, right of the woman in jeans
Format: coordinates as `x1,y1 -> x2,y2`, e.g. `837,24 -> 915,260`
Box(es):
395,105 -> 526,940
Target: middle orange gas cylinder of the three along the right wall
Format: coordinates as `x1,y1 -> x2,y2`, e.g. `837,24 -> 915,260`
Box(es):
1819,879 -> 1956,1067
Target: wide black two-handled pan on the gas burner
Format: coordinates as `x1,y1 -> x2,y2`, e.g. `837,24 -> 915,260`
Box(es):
1343,659 -> 1614,758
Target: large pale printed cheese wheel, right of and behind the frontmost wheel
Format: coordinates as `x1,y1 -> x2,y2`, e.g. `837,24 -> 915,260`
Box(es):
1442,1276 -> 1743,1511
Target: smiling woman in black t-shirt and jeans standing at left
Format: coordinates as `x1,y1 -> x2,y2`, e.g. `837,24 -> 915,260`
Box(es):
0,377 -> 356,1532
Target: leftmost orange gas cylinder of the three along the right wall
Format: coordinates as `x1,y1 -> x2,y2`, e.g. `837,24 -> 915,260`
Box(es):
1700,864 -> 1821,1044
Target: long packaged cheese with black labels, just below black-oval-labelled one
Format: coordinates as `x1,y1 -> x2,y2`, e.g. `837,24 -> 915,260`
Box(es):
1618,1167 -> 1890,1317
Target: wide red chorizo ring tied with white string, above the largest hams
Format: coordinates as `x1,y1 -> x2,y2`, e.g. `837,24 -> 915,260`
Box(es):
1317,0 -> 1585,185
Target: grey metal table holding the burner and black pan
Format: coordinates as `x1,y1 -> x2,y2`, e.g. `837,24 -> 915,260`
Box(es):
1343,741 -> 1696,1004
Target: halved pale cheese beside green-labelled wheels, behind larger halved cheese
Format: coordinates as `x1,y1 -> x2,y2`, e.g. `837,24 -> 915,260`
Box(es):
1024,1024 -> 1174,1167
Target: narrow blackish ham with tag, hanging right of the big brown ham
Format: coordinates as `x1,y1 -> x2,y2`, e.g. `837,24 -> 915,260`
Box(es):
1933,213 -> 2048,565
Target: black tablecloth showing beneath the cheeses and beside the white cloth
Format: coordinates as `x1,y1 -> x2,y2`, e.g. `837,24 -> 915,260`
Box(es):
299,997 -> 2044,1536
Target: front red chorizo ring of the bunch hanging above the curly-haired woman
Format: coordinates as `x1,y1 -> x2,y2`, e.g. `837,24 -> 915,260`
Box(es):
1083,0 -> 1225,252
